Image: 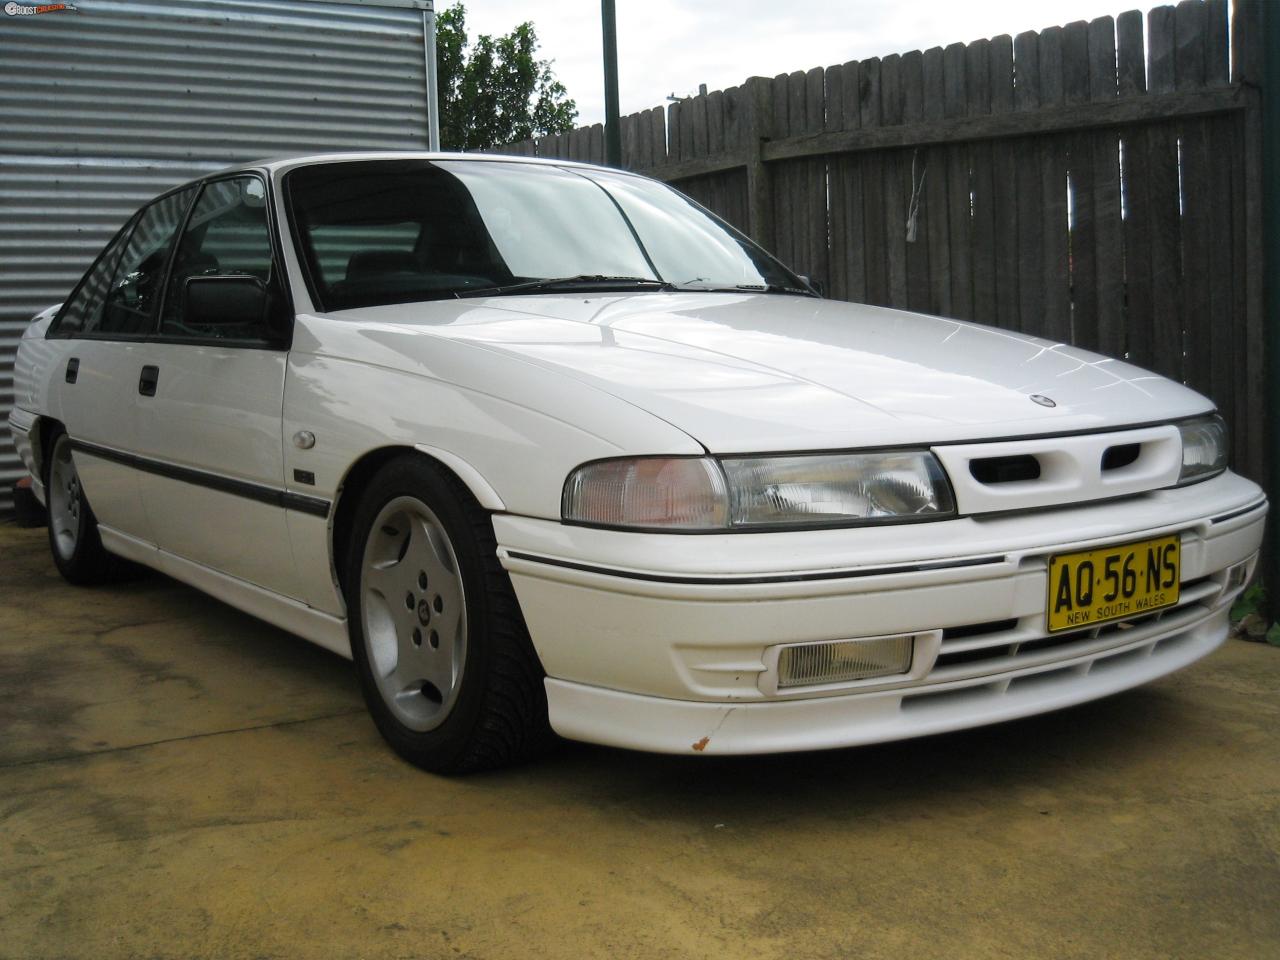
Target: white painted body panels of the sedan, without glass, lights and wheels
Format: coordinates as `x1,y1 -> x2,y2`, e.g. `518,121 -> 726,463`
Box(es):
10,155 -> 1266,753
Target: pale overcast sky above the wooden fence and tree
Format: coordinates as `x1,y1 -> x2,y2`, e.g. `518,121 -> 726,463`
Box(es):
436,0 -> 1177,125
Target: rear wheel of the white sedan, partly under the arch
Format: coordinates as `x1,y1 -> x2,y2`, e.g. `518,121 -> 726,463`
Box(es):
45,430 -> 116,586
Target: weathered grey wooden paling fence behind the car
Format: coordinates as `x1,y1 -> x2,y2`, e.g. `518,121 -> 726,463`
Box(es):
500,0 -> 1267,480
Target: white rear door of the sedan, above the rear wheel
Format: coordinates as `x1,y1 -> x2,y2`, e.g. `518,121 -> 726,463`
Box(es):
52,188 -> 196,541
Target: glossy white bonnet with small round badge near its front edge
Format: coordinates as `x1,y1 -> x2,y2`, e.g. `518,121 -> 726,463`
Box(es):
303,293 -> 1212,460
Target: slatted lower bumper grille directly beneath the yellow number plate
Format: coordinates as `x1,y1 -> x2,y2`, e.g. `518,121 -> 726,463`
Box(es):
928,577 -> 1221,682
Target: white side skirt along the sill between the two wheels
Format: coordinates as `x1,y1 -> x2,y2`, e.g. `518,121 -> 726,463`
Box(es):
99,525 -> 351,660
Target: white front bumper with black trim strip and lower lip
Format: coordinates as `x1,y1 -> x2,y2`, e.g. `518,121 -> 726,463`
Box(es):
494,474 -> 1267,753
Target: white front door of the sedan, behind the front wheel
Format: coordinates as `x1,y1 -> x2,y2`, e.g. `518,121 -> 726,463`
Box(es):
133,174 -> 298,596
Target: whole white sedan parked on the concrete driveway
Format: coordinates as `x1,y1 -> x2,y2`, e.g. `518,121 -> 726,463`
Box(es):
10,154 -> 1267,771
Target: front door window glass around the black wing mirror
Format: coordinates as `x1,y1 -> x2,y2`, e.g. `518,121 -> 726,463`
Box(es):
160,177 -> 271,340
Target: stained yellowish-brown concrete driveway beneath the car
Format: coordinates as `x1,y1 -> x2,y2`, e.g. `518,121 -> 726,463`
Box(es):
0,525 -> 1280,960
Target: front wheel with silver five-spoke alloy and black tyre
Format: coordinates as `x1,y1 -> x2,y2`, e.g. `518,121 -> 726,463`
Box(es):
343,454 -> 550,773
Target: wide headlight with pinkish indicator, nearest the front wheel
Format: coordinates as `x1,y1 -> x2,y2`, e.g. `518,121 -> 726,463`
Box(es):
563,451 -> 955,531
